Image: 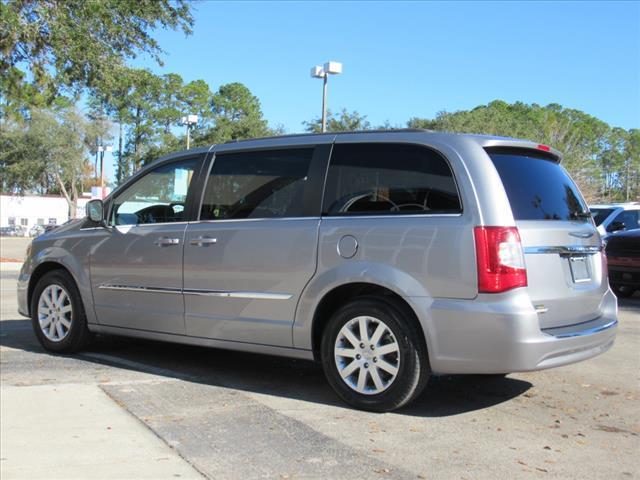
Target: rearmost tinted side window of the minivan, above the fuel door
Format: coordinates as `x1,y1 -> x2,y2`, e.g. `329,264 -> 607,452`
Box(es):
323,143 -> 461,215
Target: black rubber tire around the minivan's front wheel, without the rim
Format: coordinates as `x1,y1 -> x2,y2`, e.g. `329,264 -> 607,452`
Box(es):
31,270 -> 92,353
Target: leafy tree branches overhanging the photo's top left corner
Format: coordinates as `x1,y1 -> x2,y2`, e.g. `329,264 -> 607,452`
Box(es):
0,0 -> 193,111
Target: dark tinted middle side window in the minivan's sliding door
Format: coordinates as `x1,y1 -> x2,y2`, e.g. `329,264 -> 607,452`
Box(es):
200,148 -> 313,220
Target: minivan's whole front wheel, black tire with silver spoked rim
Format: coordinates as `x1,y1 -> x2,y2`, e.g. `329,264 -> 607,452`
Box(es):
31,270 -> 91,353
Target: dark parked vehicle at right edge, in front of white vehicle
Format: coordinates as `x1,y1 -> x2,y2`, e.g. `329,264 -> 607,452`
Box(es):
606,229 -> 640,298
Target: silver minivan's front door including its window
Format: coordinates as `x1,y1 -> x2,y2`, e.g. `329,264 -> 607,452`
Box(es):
91,157 -> 200,335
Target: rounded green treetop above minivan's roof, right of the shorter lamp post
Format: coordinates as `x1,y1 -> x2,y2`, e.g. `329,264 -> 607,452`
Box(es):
199,83 -> 271,145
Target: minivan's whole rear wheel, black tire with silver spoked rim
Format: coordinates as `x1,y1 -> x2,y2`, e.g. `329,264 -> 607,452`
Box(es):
321,297 -> 429,412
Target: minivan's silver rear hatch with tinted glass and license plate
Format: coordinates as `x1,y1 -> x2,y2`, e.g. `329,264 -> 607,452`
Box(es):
487,148 -> 608,329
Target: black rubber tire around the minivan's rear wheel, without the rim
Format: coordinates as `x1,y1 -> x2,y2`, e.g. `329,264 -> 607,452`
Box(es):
321,297 -> 430,412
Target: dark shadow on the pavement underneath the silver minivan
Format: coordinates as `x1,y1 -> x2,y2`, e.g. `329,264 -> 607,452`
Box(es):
0,320 -> 532,417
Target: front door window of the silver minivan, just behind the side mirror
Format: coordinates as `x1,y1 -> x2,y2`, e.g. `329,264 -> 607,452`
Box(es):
111,158 -> 198,225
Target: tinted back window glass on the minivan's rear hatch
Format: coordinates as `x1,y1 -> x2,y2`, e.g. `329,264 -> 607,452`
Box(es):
487,149 -> 591,221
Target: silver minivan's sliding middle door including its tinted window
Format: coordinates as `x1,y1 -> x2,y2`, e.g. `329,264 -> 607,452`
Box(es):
183,143 -> 331,347
